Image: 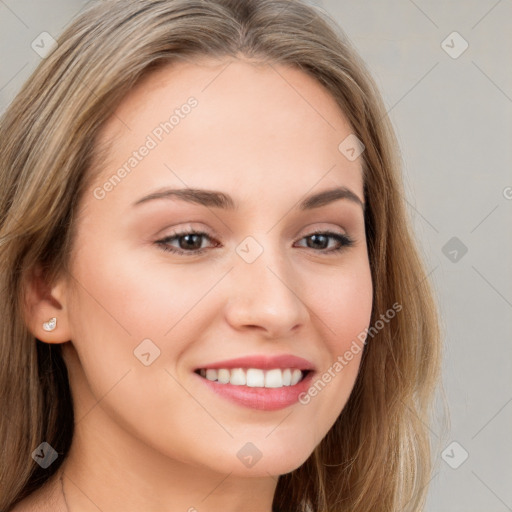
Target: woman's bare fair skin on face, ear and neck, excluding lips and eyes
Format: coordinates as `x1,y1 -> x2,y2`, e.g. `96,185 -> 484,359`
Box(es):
22,59 -> 372,512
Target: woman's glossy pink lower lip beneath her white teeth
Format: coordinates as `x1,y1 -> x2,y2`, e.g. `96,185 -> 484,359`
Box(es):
194,371 -> 314,411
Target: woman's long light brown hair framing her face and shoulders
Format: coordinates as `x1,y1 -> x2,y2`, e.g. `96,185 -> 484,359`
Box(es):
0,0 -> 448,512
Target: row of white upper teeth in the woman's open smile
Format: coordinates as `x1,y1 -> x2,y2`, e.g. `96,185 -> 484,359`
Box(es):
199,368 -> 303,388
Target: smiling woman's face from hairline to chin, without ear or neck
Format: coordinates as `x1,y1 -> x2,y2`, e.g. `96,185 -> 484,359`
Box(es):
60,60 -> 372,476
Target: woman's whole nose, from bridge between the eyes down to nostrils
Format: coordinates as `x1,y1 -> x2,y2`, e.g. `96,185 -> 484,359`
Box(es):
228,236 -> 307,336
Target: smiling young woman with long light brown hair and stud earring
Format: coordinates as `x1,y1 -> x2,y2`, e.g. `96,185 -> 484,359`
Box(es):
0,0 -> 441,512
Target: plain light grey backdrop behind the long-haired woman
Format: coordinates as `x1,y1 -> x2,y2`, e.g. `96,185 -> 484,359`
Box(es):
0,0 -> 512,512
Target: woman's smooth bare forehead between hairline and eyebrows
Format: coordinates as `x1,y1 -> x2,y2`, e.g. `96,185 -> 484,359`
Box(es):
92,59 -> 362,210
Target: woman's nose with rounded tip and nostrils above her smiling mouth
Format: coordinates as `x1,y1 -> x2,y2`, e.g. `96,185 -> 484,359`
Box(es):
225,247 -> 309,338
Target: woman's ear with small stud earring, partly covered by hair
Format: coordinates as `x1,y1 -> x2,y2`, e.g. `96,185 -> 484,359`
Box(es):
24,266 -> 71,343
